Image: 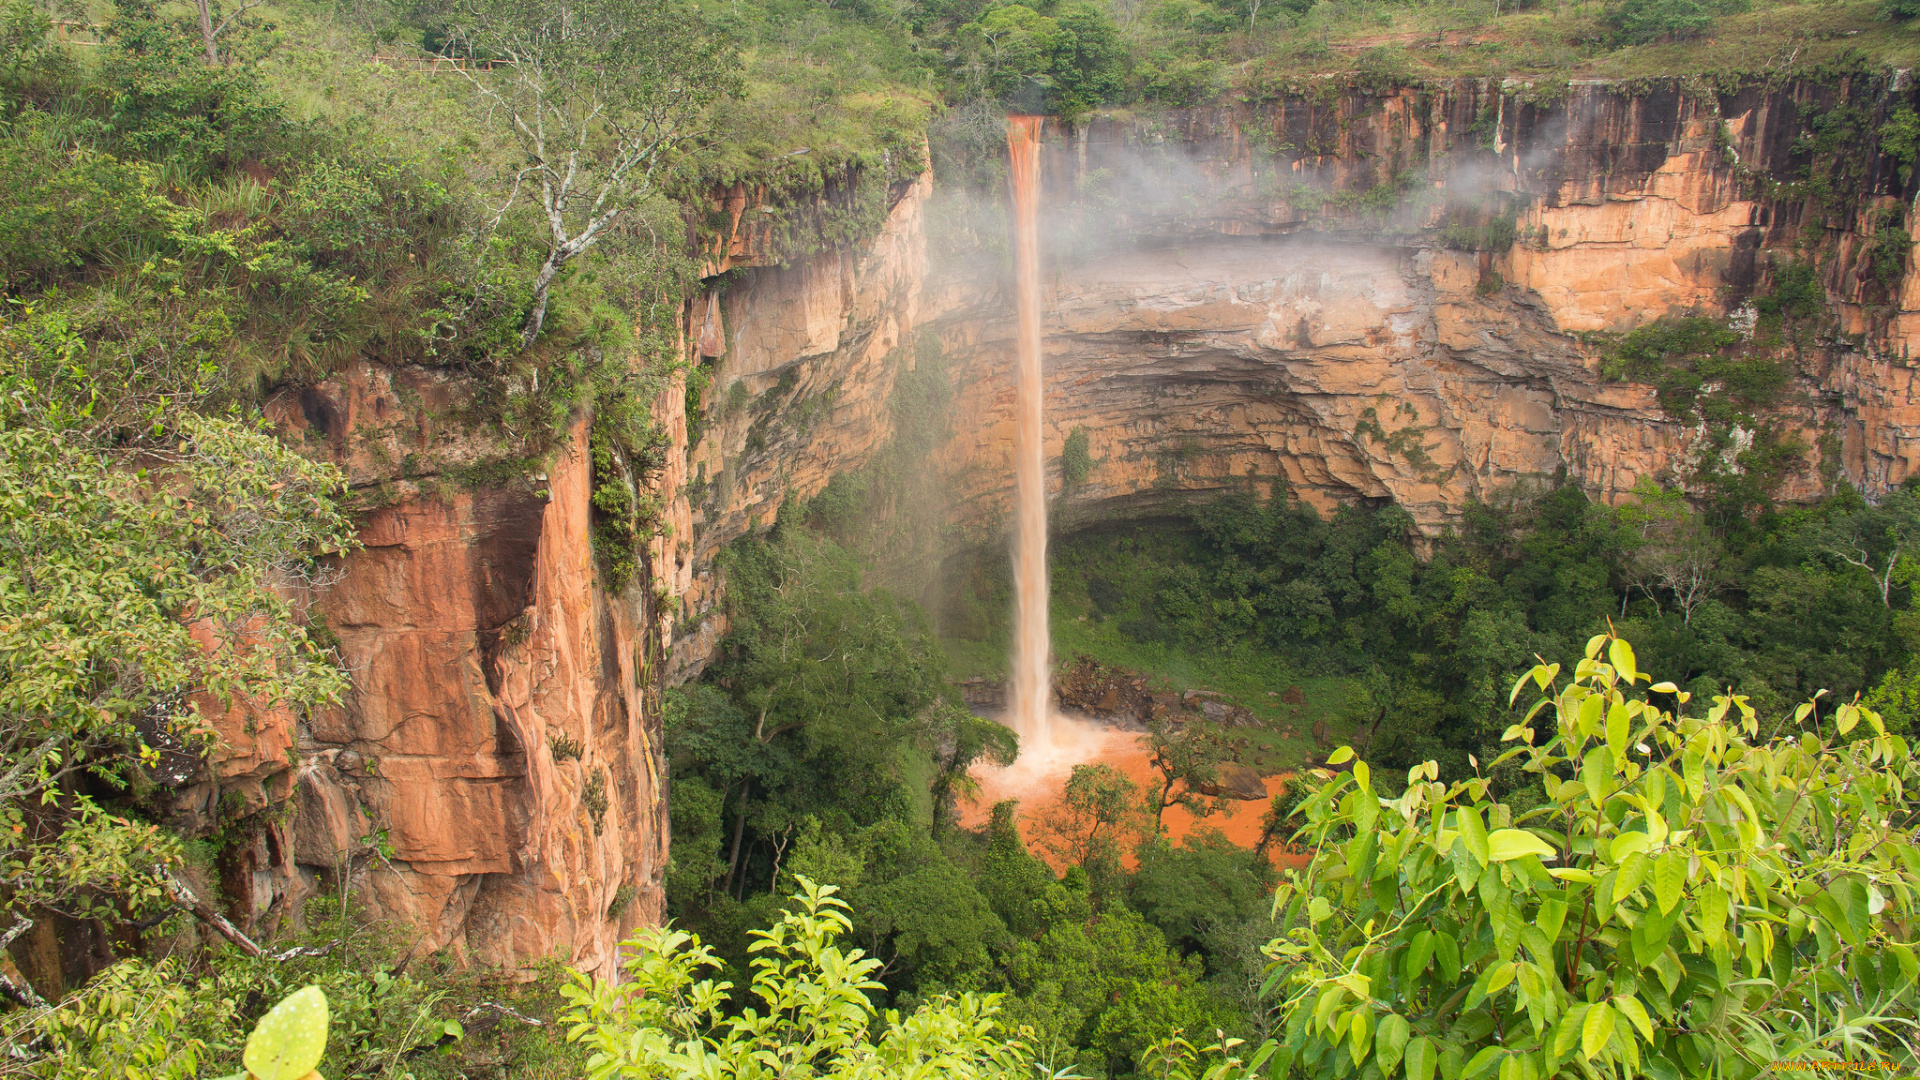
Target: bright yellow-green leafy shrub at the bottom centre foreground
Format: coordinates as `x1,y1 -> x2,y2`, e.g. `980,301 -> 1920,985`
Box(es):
563,878 -> 1029,1080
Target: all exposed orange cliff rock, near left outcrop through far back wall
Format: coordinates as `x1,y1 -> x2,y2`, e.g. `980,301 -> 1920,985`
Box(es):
165,73 -> 1920,972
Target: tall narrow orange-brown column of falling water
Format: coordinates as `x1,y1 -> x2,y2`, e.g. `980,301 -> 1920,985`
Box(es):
1006,115 -> 1052,755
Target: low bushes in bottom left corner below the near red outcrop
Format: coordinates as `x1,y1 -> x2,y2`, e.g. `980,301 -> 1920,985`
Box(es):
0,897 -> 584,1080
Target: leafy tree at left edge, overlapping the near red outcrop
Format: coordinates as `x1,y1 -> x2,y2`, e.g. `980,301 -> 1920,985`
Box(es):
0,409 -> 353,919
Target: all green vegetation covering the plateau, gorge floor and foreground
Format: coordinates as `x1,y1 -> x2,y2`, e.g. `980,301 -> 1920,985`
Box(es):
0,0 -> 1920,1080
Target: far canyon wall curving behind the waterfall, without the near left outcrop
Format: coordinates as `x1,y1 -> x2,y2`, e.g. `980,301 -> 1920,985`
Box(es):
664,77 -> 1920,678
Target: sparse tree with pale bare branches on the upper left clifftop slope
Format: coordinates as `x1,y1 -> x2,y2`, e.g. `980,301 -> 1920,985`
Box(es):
449,0 -> 739,350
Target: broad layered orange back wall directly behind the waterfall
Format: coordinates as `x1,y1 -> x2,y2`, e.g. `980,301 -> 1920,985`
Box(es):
906,85 -> 1920,532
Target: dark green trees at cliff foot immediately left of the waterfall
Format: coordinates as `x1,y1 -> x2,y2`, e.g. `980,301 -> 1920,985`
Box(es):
666,525 -> 960,919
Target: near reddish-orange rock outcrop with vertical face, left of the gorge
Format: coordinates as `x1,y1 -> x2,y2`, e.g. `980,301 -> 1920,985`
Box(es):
177,365 -> 666,974
